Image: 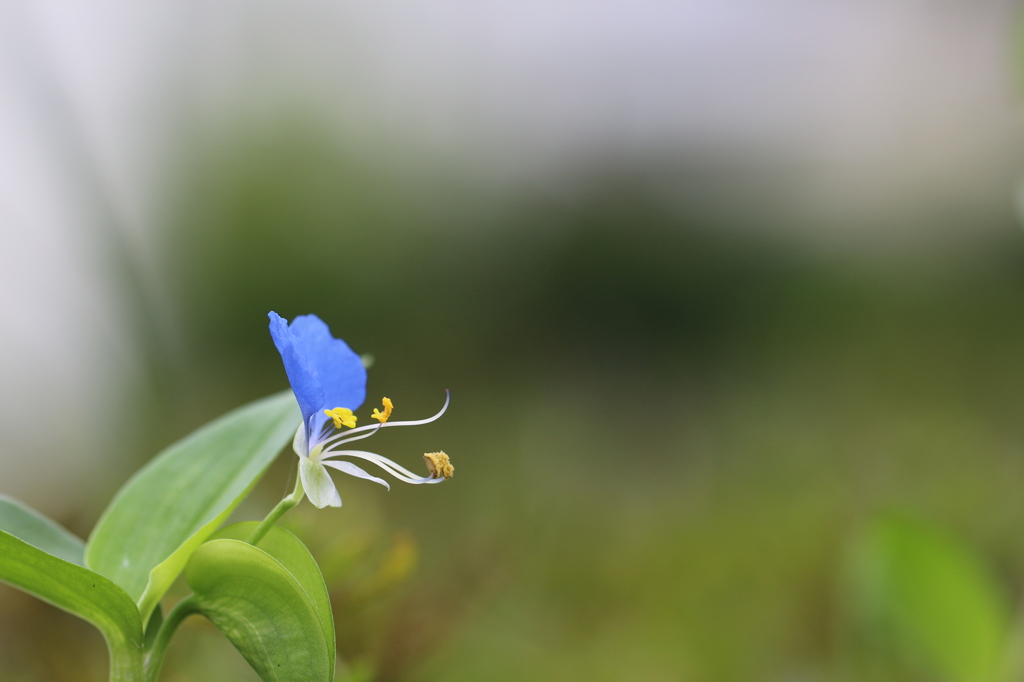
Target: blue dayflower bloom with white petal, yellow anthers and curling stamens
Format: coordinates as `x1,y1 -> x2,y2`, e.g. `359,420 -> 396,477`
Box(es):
269,312 -> 454,508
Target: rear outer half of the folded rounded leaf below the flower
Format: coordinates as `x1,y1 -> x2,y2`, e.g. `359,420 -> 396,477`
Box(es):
213,521 -> 336,680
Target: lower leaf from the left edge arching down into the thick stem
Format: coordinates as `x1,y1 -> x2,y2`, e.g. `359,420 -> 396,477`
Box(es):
0,531 -> 142,647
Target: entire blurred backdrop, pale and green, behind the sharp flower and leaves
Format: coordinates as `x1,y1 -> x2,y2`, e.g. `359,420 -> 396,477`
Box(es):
0,0 -> 1024,682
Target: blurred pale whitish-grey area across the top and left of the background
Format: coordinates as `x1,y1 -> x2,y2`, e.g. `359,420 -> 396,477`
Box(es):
0,0 -> 1022,515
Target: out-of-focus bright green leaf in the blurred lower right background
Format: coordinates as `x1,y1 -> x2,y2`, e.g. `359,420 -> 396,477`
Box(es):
855,518 -> 1010,682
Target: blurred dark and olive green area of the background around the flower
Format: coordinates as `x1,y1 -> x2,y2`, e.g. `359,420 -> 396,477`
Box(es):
0,1 -> 1024,682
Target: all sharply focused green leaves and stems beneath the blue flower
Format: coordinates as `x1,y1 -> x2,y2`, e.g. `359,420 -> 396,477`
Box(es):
0,391 -> 319,680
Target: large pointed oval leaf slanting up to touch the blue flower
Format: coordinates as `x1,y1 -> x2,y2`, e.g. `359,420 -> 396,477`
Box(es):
85,391 -> 301,621
